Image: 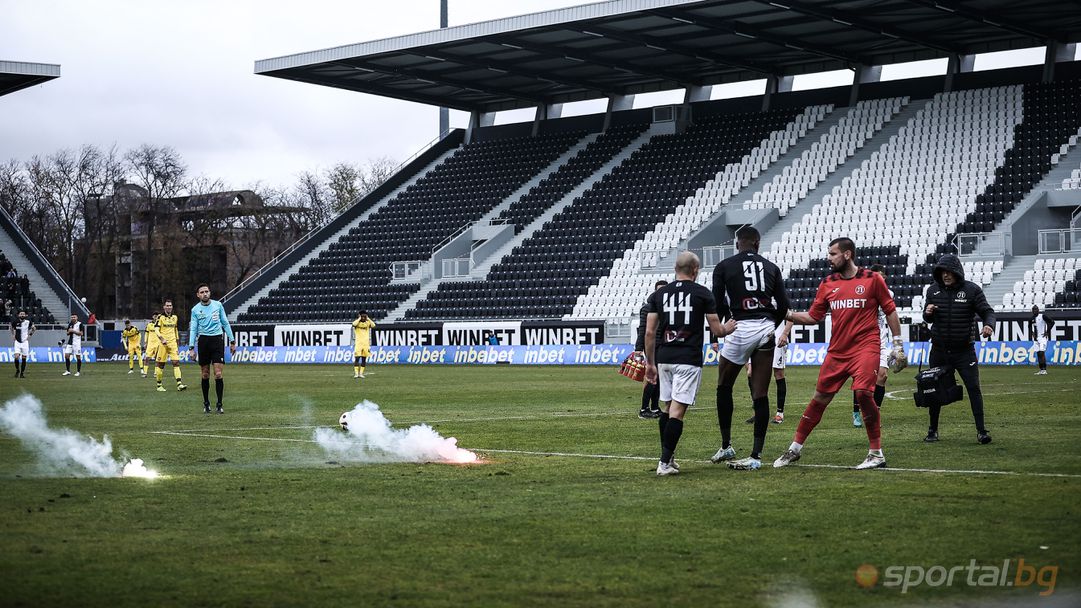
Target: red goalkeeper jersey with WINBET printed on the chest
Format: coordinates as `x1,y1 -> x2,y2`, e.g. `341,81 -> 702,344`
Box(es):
808,268 -> 897,358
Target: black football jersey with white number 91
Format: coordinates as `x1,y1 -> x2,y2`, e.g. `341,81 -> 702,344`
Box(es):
713,251 -> 790,323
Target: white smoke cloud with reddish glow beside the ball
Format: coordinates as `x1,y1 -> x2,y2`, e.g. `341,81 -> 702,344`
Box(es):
315,400 -> 478,463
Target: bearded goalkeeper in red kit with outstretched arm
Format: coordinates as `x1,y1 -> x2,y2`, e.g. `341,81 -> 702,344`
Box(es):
773,238 -> 907,470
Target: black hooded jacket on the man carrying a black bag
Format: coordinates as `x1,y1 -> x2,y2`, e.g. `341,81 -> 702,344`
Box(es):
923,253 -> 995,349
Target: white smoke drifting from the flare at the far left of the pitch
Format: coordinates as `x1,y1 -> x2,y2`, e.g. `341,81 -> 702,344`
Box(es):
0,395 -> 157,477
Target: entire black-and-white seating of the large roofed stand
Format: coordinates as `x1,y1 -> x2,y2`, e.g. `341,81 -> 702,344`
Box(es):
223,81 -> 1081,331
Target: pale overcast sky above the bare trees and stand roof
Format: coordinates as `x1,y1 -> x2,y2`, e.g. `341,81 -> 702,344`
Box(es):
0,0 -> 1055,188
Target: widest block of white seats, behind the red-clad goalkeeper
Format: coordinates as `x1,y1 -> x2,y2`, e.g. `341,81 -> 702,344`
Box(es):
771,87 -> 1022,308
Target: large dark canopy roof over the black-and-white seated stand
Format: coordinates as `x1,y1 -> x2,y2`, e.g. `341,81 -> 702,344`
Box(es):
255,0 -> 1081,111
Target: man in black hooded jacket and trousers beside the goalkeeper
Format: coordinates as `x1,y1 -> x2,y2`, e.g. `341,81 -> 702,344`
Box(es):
923,253 -> 995,444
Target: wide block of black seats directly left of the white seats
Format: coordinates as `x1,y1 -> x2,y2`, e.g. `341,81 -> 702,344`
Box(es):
406,106 -> 801,320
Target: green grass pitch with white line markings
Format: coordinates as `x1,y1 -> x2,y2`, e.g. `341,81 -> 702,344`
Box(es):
0,364 -> 1081,607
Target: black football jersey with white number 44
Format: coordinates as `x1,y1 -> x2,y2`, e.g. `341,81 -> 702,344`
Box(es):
646,280 -> 717,367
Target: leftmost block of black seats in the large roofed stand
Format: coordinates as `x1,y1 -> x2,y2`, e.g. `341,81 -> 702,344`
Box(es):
238,132 -> 585,321
